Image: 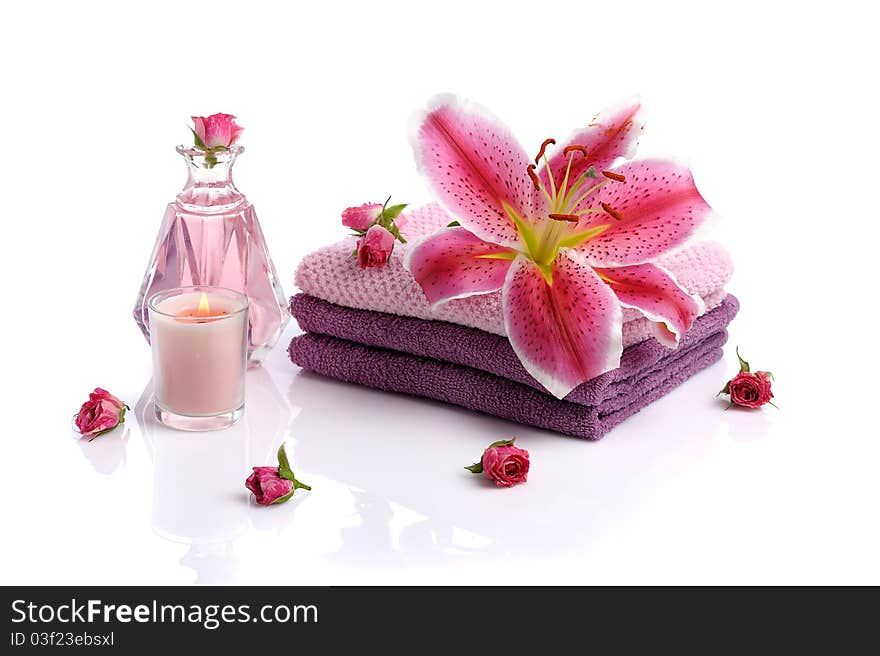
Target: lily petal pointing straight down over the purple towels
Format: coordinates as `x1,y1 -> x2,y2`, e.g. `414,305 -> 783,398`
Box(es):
502,248 -> 623,399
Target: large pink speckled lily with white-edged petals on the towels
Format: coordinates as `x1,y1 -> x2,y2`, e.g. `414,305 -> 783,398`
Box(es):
404,96 -> 711,398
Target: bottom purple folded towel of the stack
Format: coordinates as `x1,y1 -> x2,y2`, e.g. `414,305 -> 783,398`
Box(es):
289,330 -> 727,440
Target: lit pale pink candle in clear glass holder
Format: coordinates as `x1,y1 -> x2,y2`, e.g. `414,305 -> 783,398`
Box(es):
148,286 -> 248,431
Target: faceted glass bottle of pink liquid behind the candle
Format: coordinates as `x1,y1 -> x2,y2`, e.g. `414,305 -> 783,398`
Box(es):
134,145 -> 290,364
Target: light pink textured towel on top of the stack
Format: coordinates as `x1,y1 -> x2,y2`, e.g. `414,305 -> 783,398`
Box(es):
296,203 -> 733,347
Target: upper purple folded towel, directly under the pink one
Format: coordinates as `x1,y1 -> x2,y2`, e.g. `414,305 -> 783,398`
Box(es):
290,294 -> 739,404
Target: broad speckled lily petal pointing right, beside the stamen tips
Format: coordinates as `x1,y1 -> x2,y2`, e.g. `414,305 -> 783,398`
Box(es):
578,160 -> 712,267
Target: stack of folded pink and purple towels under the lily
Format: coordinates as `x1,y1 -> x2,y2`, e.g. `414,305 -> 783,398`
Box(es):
289,205 -> 739,440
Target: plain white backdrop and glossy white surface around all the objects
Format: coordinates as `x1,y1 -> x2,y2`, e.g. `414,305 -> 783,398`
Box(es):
0,0 -> 880,584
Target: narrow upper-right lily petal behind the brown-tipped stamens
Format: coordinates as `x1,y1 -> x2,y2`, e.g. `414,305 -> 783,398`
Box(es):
539,98 -> 644,188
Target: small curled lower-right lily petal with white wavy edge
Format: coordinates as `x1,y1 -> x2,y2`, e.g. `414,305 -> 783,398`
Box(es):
596,264 -> 706,348
